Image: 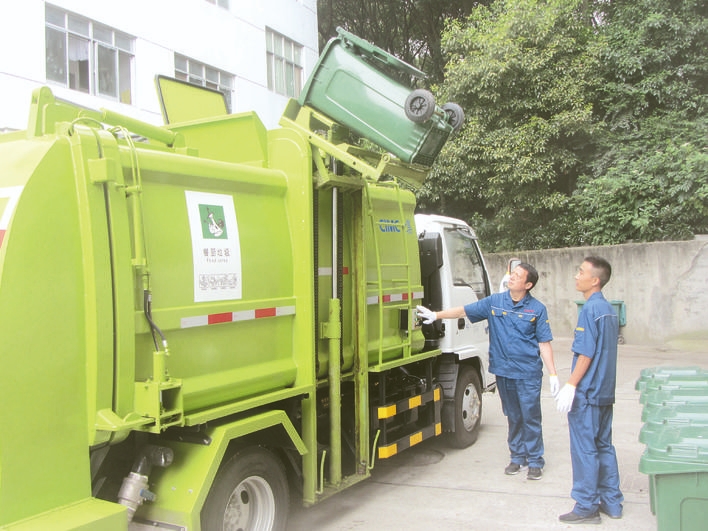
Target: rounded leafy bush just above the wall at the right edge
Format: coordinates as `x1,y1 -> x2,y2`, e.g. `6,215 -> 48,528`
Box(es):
574,114 -> 708,245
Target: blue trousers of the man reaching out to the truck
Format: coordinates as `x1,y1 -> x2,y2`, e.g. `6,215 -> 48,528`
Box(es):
497,376 -> 546,468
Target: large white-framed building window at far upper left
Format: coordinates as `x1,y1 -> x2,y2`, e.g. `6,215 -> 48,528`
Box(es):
45,4 -> 135,103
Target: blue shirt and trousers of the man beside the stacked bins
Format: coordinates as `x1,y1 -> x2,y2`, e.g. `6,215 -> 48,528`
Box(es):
568,292 -> 624,516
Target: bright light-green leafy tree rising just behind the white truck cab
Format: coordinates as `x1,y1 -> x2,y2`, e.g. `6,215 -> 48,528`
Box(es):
419,0 -> 600,250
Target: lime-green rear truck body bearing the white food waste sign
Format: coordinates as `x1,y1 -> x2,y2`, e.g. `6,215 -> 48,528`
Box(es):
0,85 -> 317,525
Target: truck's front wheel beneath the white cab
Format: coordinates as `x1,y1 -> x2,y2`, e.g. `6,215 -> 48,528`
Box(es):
450,365 -> 482,448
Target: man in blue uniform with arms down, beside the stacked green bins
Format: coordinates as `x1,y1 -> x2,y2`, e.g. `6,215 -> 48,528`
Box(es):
556,256 -> 624,524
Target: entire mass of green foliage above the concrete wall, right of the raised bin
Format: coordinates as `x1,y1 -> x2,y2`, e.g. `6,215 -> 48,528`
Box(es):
419,0 -> 708,250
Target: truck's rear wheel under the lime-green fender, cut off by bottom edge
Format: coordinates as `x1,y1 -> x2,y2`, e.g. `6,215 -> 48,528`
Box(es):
201,448 -> 290,531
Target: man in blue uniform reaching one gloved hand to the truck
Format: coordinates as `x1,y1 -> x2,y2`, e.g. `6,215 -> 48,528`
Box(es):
417,263 -> 560,480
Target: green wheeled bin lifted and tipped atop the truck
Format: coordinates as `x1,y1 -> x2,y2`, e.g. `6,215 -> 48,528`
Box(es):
298,28 -> 464,166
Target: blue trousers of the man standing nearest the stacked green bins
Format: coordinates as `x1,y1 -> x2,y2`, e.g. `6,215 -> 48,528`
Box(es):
568,402 -> 624,516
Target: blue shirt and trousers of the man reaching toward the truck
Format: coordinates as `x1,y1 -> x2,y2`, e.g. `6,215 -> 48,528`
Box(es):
465,291 -> 553,468
